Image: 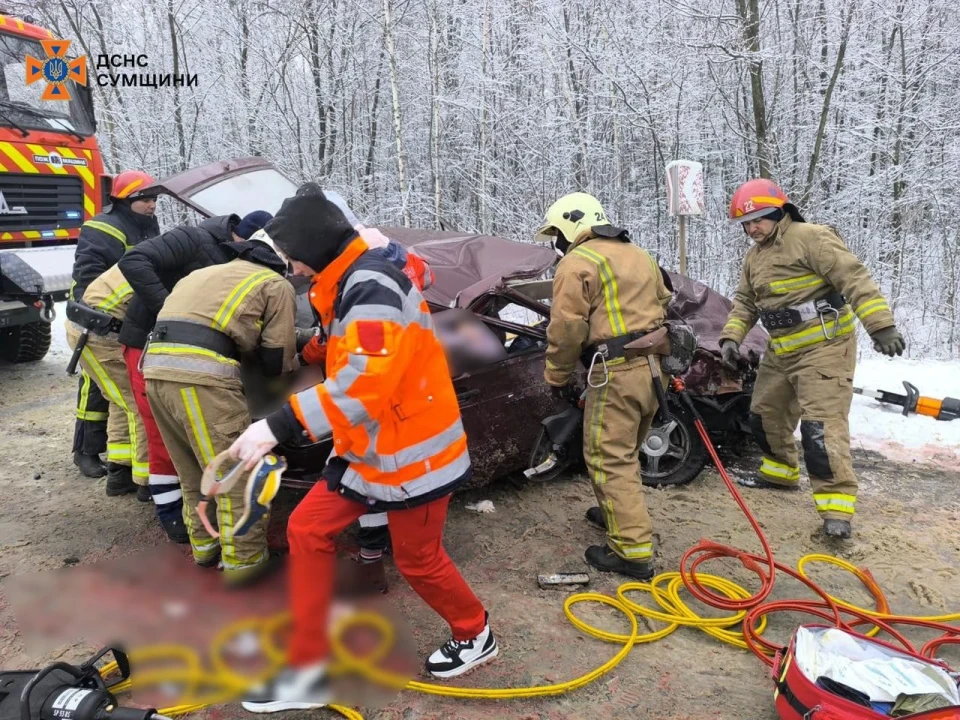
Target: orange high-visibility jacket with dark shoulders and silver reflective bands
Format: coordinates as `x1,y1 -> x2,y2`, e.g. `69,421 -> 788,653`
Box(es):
268,237 -> 470,509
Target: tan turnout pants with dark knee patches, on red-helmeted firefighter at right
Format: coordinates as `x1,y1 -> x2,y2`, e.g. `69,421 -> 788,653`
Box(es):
750,333 -> 857,520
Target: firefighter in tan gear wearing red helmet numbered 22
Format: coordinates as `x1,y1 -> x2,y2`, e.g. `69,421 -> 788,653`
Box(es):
720,179 -> 904,538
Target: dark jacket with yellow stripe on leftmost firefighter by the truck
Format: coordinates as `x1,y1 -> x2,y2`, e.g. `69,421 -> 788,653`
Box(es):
70,203 -> 160,300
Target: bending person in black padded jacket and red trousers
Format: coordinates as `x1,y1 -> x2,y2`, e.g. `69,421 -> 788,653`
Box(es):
120,210 -> 272,539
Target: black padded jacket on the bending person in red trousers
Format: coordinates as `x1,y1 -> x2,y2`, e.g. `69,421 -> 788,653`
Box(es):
120,215 -> 240,349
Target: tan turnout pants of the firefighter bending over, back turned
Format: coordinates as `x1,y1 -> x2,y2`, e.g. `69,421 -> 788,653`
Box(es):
146,378 -> 269,576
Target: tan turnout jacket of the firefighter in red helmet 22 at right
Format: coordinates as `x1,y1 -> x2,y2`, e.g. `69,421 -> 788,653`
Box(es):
720,215 -> 894,355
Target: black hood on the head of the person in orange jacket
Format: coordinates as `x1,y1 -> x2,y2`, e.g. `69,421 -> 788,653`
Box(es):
264,183 -> 358,272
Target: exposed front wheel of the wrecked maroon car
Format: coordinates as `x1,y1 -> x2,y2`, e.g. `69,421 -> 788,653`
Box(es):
640,403 -> 709,487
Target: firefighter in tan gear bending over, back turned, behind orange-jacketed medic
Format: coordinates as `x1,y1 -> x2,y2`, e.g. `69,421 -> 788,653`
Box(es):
143,236 -> 296,587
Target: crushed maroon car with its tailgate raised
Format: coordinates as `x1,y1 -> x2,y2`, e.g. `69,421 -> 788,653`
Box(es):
157,157 -> 766,489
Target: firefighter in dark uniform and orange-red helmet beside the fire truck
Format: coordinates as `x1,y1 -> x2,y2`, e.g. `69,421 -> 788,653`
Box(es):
70,170 -> 160,496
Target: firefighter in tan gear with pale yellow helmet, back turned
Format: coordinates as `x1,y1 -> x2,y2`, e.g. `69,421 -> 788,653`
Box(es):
537,193 -> 671,580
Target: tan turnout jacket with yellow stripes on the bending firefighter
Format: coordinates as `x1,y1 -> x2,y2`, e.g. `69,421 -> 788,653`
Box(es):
143,258 -> 297,388
